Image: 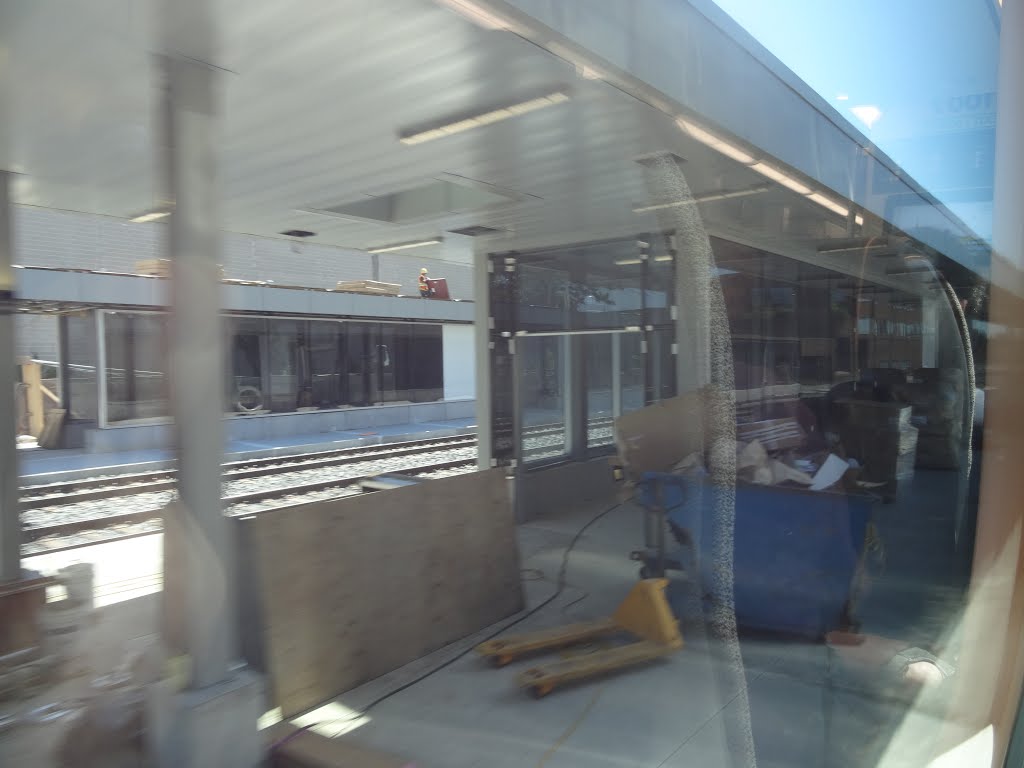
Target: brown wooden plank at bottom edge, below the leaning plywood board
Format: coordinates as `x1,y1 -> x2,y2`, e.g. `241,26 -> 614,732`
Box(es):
263,722 -> 412,768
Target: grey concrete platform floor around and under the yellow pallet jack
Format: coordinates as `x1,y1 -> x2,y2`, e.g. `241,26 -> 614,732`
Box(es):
323,495 -> 954,768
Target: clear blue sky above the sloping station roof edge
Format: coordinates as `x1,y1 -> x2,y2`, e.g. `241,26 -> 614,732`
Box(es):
715,0 -> 998,239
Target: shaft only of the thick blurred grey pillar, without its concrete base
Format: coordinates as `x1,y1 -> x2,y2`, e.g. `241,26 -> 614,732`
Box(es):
163,55 -> 234,688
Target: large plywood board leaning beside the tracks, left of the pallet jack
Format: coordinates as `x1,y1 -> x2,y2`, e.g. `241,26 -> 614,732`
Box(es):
252,469 -> 522,717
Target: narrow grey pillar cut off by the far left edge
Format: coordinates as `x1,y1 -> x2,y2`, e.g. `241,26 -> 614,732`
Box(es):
0,171 -> 22,583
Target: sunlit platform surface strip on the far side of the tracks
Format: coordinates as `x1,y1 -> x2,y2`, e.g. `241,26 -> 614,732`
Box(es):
18,418 -> 476,484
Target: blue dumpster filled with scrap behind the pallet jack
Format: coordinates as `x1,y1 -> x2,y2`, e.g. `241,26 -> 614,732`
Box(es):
638,472 -> 874,637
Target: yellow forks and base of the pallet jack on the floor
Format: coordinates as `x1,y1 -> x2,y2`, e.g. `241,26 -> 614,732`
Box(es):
476,579 -> 683,698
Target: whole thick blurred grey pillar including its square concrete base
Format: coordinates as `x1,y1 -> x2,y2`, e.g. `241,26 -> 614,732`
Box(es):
145,0 -> 264,768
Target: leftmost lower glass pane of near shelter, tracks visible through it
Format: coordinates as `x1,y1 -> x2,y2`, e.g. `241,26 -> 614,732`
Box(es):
517,336 -> 571,462
